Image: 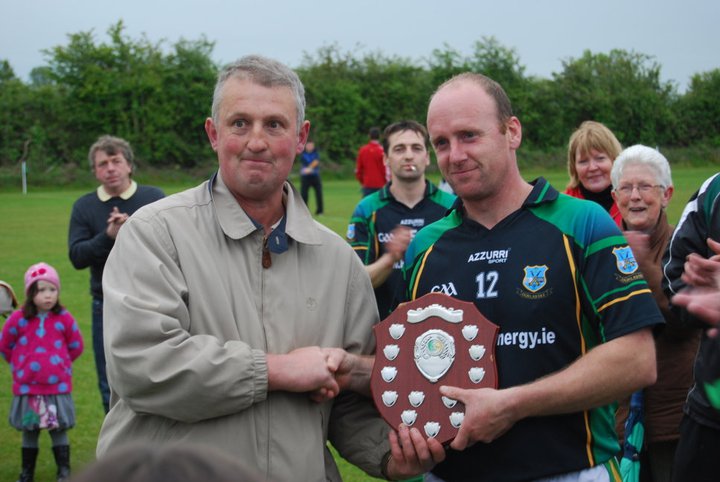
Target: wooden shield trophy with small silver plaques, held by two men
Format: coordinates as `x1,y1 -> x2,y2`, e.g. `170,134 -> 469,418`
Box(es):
370,293 -> 499,443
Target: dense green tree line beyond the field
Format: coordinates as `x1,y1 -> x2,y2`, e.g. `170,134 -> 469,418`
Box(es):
0,21 -> 720,168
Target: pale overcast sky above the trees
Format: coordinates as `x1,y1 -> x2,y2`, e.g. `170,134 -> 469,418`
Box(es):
0,0 -> 720,91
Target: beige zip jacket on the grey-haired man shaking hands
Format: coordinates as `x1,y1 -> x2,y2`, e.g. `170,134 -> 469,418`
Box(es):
97,174 -> 389,481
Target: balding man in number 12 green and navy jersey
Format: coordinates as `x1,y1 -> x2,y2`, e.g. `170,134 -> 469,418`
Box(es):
394,73 -> 663,482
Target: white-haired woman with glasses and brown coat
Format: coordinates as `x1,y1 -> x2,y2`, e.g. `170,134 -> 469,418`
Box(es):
611,145 -> 699,482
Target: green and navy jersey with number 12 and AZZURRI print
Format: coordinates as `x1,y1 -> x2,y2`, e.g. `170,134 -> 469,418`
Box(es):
399,178 -> 663,481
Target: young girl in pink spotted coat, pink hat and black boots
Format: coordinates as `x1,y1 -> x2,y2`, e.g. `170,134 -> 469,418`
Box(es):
0,263 -> 83,482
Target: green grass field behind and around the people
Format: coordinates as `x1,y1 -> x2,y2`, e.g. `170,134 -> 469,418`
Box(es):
0,167 -> 717,481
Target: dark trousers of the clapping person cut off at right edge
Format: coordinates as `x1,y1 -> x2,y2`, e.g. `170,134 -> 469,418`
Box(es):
672,415 -> 720,482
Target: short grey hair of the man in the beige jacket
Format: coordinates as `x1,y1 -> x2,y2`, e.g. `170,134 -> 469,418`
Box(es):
212,55 -> 305,132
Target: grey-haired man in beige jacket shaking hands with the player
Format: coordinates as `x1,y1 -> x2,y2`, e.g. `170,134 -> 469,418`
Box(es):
97,56 -> 443,481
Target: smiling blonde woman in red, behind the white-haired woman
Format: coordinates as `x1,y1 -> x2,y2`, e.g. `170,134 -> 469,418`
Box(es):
565,121 -> 622,226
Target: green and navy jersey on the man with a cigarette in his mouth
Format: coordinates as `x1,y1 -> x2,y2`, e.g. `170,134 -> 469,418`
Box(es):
347,181 -> 455,319
